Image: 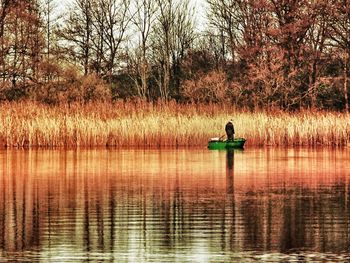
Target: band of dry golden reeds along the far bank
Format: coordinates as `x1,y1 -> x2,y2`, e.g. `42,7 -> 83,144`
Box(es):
0,102 -> 350,147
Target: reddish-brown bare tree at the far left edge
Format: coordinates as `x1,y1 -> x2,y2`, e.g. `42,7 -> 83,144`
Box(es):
1,0 -> 43,89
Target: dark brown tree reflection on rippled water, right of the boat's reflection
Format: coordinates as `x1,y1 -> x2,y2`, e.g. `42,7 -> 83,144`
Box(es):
237,177 -> 350,253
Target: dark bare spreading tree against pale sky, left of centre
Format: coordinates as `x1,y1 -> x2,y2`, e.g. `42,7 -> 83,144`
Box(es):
59,0 -> 131,81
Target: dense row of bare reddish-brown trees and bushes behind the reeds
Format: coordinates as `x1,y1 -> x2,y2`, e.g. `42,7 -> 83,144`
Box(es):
0,0 -> 350,111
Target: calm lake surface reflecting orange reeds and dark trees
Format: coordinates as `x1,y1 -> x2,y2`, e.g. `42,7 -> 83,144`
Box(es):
0,148 -> 350,262
